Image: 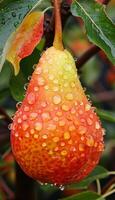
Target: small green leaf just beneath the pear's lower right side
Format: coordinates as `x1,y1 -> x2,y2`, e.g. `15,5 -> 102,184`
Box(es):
67,166 -> 109,189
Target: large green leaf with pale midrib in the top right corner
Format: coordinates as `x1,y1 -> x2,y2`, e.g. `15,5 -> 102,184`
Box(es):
71,0 -> 115,63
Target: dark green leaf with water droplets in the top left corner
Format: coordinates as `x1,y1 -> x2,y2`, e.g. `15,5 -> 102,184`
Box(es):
0,0 -> 51,55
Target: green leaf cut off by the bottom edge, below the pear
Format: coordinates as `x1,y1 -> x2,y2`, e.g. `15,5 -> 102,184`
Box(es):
60,191 -> 104,200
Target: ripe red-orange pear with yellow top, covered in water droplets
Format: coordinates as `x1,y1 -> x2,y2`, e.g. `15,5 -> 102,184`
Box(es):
11,47 -> 104,186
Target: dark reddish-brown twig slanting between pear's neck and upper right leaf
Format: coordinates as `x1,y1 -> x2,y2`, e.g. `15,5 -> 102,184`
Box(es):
76,45 -> 101,69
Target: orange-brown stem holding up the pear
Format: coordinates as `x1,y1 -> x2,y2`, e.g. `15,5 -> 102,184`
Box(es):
53,0 -> 64,50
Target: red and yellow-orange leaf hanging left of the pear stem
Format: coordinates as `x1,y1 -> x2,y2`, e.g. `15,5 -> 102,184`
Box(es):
0,11 -> 44,75
